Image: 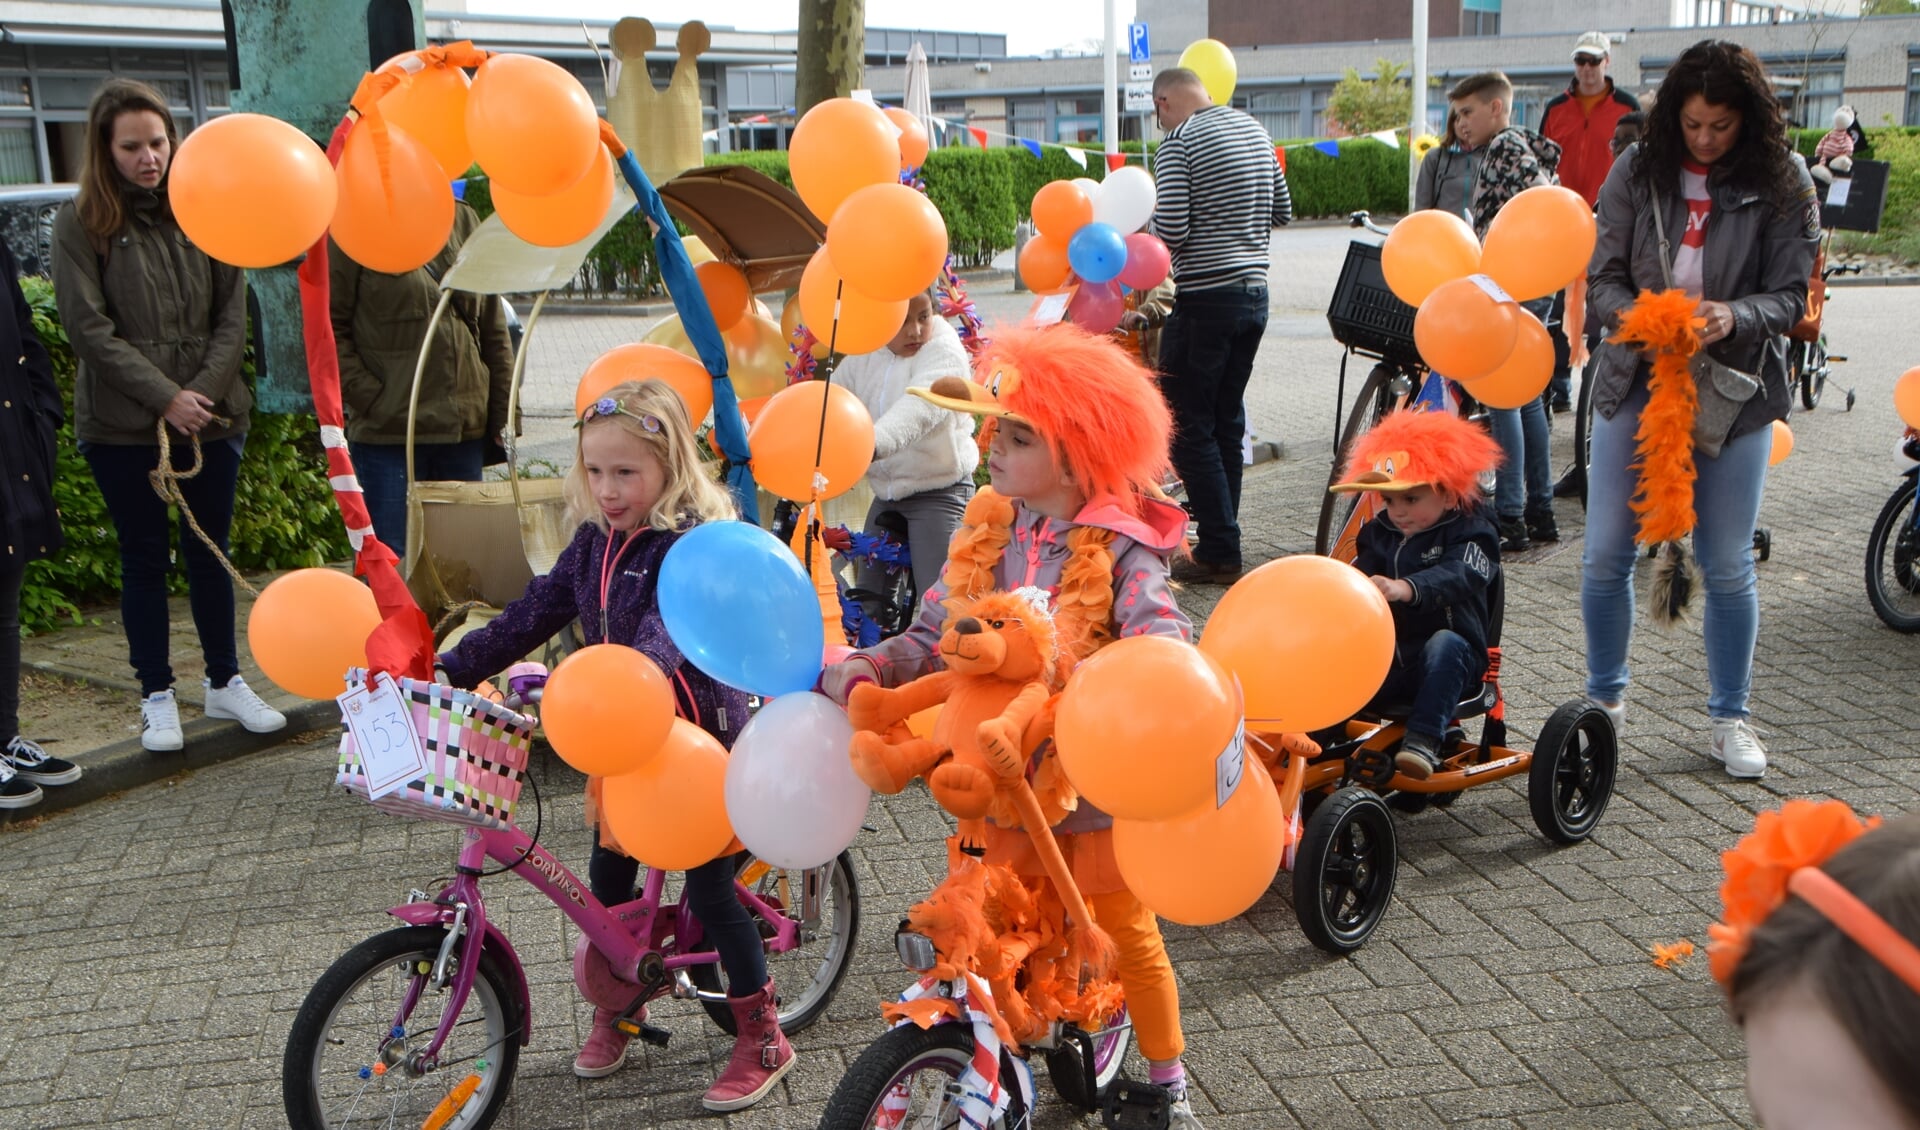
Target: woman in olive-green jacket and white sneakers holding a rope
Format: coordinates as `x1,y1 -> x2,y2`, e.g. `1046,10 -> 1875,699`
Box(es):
54,79 -> 286,750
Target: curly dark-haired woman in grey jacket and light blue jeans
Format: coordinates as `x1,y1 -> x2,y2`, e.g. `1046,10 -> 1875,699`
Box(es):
1580,40 -> 1820,779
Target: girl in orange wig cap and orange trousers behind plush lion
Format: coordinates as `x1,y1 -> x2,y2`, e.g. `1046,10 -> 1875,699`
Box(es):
820,324 -> 1200,1130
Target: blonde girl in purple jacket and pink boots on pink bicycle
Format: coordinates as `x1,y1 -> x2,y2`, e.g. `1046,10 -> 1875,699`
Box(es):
438,380 -> 793,1111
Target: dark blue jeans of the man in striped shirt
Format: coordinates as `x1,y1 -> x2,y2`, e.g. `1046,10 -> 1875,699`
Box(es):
1160,284 -> 1267,566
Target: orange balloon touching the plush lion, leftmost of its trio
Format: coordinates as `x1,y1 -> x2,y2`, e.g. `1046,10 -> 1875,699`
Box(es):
1054,635 -> 1246,819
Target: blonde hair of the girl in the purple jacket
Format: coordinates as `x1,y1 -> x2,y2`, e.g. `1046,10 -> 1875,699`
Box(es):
563,378 -> 739,530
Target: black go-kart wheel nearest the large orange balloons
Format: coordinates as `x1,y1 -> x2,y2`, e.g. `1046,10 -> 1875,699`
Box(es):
1294,785 -> 1400,953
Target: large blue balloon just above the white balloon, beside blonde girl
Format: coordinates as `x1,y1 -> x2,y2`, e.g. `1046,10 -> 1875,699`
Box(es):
657,522 -> 826,698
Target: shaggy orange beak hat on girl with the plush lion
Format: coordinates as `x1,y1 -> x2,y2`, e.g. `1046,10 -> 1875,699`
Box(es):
908,316 -> 1173,510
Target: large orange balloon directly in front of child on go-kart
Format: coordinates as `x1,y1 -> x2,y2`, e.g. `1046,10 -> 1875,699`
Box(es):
1200,554 -> 1394,733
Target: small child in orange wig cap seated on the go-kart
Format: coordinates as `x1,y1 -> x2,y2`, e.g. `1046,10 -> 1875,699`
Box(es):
1331,411 -> 1500,781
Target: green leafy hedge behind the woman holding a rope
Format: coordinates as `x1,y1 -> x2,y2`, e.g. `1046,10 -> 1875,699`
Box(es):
19,278 -> 351,633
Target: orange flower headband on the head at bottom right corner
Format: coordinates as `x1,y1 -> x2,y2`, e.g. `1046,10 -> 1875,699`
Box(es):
1707,800 -> 1920,992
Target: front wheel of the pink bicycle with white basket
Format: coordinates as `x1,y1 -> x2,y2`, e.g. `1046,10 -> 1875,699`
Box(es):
280,927 -> 526,1130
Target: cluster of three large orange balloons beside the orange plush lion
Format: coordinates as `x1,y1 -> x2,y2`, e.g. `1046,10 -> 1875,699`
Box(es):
1054,556 -> 1394,925
